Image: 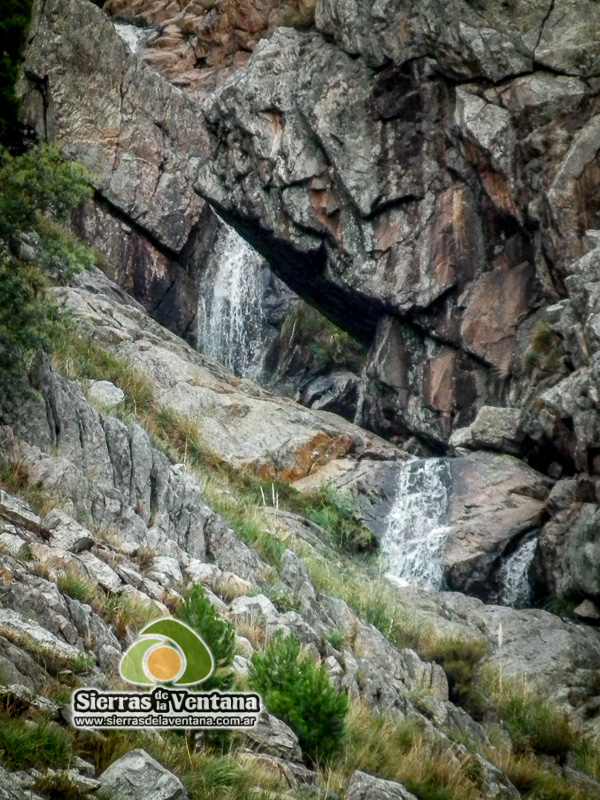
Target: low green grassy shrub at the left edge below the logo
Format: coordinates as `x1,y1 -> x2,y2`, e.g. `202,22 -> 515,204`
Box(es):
0,717 -> 71,769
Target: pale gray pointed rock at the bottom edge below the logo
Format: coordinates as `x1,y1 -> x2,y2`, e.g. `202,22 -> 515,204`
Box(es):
100,750 -> 188,800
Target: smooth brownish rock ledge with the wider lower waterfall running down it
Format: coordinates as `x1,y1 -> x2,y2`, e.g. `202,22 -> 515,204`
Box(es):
304,452 -> 552,601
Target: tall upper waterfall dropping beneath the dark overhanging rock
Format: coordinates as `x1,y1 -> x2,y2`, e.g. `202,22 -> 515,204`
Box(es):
198,222 -> 265,380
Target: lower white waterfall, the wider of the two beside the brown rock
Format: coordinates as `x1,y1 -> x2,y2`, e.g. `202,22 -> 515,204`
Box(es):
381,458 -> 450,590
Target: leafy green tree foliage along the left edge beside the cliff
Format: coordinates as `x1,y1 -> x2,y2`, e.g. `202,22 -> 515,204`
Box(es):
0,146 -> 94,393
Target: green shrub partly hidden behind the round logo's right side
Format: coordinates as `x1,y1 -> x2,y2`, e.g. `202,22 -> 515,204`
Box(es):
177,584 -> 236,691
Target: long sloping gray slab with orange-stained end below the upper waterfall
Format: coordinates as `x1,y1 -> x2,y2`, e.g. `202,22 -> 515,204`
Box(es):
52,271 -> 403,482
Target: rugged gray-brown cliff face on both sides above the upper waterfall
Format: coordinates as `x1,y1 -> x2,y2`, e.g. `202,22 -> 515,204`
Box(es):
25,0 -> 598,460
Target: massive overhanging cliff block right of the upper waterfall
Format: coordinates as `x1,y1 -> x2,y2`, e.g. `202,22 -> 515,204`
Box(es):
196,2 -> 598,443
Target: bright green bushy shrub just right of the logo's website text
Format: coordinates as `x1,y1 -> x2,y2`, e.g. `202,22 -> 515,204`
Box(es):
249,634 -> 348,763
